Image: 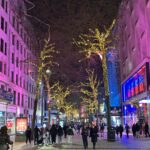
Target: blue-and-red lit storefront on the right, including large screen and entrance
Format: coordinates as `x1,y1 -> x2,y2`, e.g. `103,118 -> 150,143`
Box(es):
122,62 -> 150,126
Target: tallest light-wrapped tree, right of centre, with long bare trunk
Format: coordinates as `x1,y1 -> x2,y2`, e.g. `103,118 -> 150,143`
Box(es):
74,20 -> 116,140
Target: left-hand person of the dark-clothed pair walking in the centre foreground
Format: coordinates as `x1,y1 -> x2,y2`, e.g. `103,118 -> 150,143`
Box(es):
81,125 -> 89,149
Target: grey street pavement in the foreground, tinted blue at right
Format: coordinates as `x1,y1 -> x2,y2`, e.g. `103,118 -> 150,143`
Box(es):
13,135 -> 150,150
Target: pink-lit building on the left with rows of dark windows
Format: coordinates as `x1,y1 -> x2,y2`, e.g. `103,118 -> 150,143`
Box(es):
0,0 -> 36,134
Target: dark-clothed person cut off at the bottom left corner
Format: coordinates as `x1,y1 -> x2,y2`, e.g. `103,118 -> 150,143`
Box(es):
0,126 -> 13,150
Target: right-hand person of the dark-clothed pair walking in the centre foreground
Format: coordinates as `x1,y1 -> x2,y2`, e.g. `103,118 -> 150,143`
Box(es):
90,123 -> 98,149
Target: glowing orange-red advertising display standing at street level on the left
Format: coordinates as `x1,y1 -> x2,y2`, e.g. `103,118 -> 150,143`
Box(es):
16,118 -> 28,134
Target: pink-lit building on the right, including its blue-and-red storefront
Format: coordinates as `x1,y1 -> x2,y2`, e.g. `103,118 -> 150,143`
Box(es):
117,0 -> 150,125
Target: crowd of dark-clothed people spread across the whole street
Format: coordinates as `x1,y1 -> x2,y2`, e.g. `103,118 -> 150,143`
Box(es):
0,122 -> 150,150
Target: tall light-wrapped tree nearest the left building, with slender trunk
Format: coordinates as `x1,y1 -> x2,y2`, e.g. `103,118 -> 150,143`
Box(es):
25,37 -> 57,137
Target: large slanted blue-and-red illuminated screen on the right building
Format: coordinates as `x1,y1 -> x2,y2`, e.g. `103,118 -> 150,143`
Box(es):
122,63 -> 148,101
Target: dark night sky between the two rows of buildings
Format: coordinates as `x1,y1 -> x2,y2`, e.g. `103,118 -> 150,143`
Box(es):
27,0 -> 121,85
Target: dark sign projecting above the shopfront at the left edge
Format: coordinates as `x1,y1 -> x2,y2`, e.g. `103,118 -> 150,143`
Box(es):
0,88 -> 14,102
